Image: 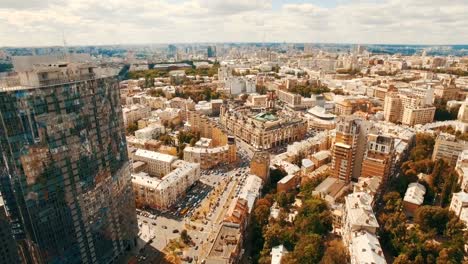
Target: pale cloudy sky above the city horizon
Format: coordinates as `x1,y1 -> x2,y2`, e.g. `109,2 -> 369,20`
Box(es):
0,0 -> 468,47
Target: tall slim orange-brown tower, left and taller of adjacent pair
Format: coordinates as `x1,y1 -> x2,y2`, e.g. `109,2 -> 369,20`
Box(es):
332,116 -> 368,183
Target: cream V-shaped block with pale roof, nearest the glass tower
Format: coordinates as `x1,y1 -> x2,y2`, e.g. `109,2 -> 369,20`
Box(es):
132,160 -> 200,210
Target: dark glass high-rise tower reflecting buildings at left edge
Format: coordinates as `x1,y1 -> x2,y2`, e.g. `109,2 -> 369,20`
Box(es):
0,55 -> 137,263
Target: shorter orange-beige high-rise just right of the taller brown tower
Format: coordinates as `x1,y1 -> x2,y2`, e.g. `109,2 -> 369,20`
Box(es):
361,133 -> 395,184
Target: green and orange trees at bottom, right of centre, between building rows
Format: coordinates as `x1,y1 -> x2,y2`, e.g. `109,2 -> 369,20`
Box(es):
247,170 -> 348,264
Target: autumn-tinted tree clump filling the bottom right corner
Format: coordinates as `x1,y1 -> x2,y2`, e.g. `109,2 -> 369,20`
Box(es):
378,192 -> 467,264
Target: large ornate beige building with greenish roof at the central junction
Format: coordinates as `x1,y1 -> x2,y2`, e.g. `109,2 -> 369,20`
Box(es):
220,105 -> 307,150
